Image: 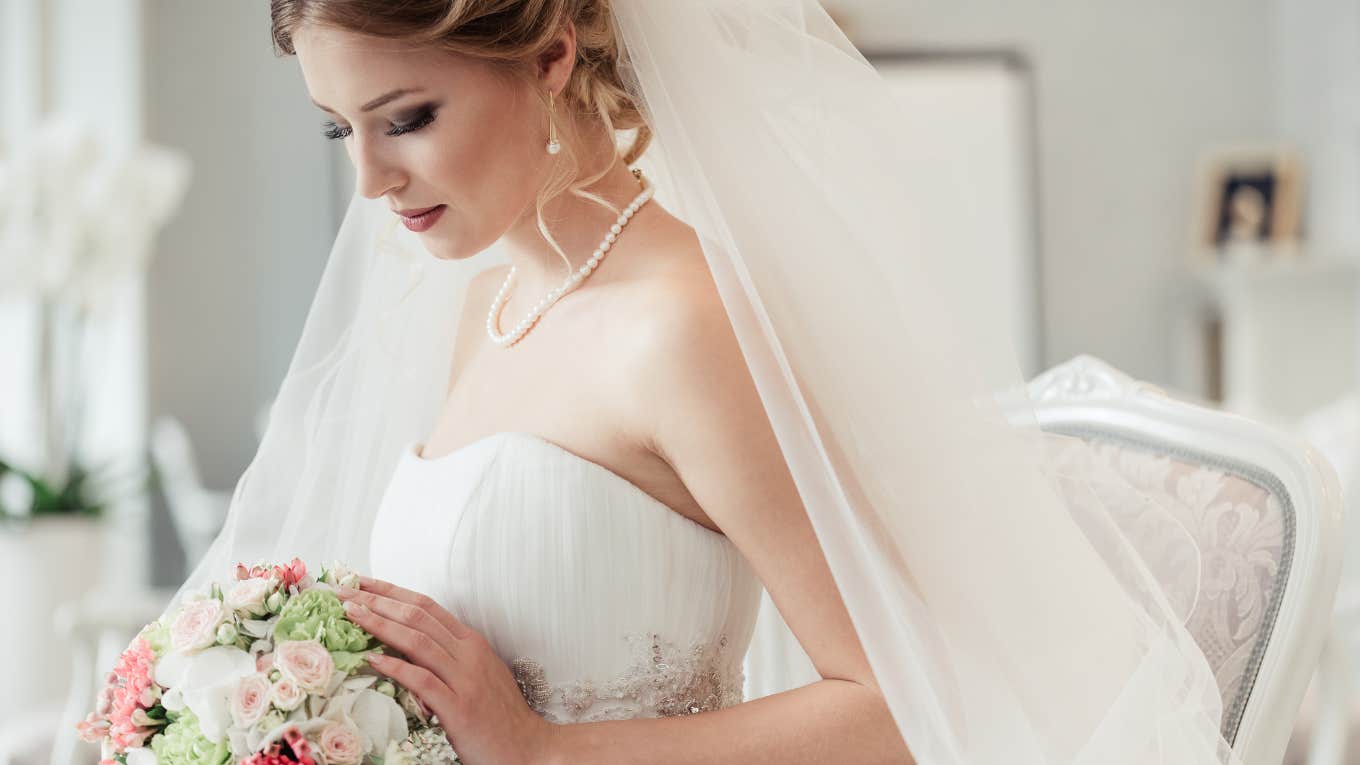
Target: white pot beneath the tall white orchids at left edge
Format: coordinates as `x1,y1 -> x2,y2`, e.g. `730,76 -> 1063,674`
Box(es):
0,516 -> 106,720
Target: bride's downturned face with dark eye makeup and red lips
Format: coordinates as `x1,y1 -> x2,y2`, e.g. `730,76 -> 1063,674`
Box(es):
292,25 -> 549,259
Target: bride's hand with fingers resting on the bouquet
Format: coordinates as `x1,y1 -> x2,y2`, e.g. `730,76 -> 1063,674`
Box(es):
337,577 -> 554,765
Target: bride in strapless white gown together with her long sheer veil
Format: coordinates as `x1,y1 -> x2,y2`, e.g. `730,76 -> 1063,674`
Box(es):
184,0 -> 1231,765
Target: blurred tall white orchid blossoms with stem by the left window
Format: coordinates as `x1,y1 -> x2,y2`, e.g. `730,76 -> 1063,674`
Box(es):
0,111 -> 189,495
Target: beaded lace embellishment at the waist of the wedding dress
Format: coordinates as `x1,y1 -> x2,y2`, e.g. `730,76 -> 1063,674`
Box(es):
510,634 -> 744,723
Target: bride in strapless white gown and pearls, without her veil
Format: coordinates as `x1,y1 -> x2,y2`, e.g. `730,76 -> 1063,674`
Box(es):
273,0 -> 906,765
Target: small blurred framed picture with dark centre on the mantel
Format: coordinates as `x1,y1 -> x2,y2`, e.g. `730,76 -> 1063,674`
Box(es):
1194,147 -> 1303,263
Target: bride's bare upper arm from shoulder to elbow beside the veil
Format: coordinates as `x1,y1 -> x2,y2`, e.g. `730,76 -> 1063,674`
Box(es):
641,270 -> 874,686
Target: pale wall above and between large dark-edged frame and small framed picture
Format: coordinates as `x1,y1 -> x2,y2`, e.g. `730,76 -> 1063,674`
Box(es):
828,0 -> 1274,381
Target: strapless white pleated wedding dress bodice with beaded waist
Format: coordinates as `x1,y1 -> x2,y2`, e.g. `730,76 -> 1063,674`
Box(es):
370,433 -> 762,723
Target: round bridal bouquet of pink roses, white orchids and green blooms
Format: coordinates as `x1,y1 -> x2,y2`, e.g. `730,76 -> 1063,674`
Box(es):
78,558 -> 458,765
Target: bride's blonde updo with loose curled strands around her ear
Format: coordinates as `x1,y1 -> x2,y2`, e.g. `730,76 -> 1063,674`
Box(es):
269,0 -> 651,267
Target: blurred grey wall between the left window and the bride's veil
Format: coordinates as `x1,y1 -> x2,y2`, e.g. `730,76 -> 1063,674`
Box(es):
148,0 -> 339,506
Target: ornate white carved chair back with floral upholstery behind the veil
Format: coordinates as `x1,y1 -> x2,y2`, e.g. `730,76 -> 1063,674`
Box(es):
1028,355 -> 1341,765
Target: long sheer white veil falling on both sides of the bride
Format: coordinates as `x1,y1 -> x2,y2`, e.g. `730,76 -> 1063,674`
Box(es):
181,0 -> 1231,765
